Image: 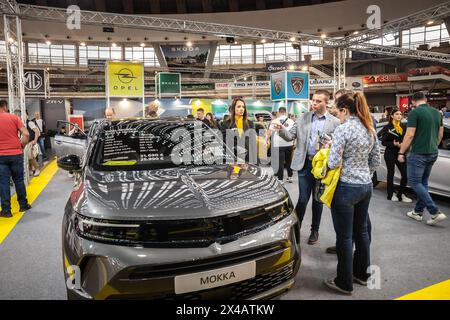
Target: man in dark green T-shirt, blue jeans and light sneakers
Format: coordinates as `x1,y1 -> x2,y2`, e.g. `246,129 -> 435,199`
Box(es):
398,92 -> 447,225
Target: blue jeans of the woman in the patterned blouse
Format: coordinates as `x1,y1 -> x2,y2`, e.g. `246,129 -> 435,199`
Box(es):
331,182 -> 372,291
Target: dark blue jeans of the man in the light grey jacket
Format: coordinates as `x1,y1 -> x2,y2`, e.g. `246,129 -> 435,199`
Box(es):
295,158 -> 323,231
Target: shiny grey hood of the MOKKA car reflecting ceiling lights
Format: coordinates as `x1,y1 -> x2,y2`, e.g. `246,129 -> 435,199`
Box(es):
71,165 -> 287,220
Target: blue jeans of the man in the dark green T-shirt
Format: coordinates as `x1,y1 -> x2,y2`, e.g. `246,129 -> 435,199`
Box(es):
407,153 -> 439,215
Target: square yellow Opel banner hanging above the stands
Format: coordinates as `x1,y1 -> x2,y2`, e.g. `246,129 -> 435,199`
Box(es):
107,61 -> 144,98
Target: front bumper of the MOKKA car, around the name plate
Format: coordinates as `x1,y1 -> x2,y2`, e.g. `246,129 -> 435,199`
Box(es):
63,213 -> 300,300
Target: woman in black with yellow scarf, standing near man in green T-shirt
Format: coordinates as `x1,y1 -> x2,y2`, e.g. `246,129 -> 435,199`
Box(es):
381,108 -> 412,203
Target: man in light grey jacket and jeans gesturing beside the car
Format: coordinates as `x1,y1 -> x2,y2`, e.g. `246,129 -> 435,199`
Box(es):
274,90 -> 340,245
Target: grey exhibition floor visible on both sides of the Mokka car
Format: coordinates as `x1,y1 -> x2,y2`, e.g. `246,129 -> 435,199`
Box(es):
0,170 -> 450,300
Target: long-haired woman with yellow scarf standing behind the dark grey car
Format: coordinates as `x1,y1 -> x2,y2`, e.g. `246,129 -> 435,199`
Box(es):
220,98 -> 258,163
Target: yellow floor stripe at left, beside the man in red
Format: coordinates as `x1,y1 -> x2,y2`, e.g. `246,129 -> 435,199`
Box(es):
0,160 -> 58,244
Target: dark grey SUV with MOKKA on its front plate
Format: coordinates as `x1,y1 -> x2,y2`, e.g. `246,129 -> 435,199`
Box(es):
58,118 -> 300,299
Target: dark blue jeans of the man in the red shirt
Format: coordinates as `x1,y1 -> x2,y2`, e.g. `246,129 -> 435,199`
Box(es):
0,154 -> 28,212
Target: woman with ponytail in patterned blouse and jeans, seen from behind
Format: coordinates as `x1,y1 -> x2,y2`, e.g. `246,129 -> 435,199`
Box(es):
325,92 -> 381,294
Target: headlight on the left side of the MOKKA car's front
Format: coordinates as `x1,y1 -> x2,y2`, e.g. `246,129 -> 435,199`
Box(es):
74,214 -> 140,242
